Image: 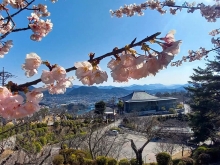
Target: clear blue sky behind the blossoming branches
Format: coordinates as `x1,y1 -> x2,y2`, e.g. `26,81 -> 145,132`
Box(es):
0,0 -> 219,86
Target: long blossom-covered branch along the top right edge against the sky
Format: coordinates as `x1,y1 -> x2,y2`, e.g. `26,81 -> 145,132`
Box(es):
110,0 -> 220,22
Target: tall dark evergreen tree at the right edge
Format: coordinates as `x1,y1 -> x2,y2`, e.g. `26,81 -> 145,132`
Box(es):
186,51 -> 220,143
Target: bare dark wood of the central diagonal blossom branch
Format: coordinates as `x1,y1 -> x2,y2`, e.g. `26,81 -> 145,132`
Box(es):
16,32 -> 161,89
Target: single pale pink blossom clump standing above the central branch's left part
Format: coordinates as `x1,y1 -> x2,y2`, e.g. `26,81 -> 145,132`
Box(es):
22,53 -> 42,77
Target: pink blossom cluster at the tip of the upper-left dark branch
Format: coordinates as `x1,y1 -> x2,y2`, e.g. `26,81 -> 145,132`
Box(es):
28,13 -> 53,41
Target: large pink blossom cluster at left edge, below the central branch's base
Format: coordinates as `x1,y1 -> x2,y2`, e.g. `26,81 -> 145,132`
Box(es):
0,86 -> 44,119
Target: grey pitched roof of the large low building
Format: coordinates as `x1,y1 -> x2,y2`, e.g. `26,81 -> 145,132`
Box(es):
119,91 -> 176,102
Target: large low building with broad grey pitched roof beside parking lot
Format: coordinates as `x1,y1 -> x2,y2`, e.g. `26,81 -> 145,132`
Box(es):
119,91 -> 177,113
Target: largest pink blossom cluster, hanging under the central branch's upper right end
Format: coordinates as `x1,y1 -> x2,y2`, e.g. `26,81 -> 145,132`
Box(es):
108,41 -> 181,82
